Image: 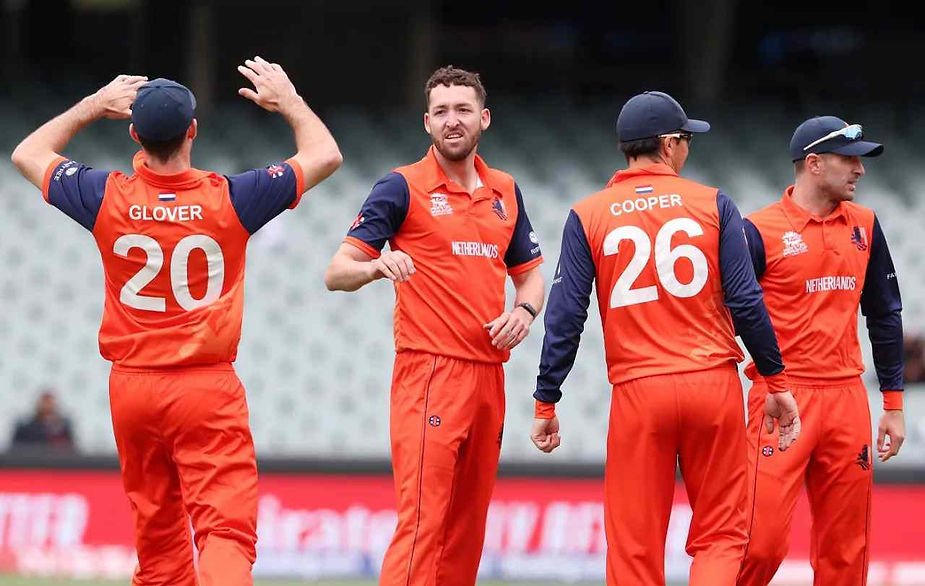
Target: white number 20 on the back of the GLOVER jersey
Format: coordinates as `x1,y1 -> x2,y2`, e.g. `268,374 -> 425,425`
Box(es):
112,234 -> 225,311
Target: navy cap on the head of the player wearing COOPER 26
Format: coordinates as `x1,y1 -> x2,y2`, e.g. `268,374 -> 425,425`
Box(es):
617,91 -> 710,142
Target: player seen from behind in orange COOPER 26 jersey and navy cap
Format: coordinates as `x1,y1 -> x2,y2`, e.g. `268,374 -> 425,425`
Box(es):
532,91 -> 800,586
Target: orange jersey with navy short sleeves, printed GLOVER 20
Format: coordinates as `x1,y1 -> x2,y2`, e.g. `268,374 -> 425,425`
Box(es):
43,152 -> 303,368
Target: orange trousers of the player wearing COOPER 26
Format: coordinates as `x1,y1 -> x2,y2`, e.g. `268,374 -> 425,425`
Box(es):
604,364 -> 747,586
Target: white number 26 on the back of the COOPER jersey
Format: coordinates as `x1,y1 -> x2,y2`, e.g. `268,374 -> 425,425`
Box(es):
604,218 -> 707,309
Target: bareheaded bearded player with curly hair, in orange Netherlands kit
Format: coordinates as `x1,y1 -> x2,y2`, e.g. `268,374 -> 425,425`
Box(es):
325,66 -> 544,586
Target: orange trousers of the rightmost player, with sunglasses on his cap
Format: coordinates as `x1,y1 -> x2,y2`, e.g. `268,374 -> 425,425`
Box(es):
738,377 -> 873,586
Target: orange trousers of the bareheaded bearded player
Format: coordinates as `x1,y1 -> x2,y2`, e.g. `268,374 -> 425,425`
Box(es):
379,351 -> 504,586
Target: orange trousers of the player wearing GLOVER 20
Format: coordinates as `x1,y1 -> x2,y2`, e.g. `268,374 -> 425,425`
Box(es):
109,364 -> 257,586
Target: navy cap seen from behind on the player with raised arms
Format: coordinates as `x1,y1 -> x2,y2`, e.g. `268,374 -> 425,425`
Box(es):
132,77 -> 196,142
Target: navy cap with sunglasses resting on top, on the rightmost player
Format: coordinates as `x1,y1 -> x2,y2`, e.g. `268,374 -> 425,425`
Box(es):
790,116 -> 883,163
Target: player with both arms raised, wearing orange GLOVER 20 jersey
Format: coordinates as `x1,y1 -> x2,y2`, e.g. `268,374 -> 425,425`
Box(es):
13,57 -> 341,586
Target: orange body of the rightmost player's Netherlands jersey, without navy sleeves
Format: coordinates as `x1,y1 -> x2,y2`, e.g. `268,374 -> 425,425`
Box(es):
746,186 -> 872,378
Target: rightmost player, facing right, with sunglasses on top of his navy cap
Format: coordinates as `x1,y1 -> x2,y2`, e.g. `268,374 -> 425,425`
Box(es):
738,116 -> 905,586
